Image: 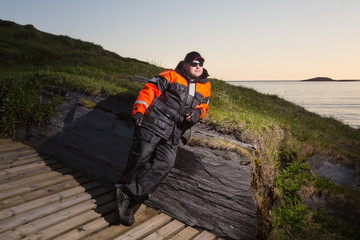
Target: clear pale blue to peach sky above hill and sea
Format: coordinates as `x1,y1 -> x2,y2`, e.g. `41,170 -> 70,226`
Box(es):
0,0 -> 360,81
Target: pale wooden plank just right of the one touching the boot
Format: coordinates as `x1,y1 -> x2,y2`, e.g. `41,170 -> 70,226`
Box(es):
115,213 -> 171,240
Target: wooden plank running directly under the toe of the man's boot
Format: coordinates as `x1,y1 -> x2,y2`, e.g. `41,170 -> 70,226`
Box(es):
87,205 -> 157,240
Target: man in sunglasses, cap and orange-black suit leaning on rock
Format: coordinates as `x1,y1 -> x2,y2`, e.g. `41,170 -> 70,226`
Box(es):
115,52 -> 211,226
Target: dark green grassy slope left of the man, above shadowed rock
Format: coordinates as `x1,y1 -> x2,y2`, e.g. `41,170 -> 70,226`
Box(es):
0,21 -> 162,136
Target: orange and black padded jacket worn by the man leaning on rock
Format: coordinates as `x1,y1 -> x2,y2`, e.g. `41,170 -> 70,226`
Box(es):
132,61 -> 211,140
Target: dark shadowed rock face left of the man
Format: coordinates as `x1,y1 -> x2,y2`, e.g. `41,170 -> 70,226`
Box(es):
23,92 -> 132,185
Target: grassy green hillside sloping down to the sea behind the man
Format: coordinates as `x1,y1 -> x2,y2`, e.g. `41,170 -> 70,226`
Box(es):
0,20 -> 360,239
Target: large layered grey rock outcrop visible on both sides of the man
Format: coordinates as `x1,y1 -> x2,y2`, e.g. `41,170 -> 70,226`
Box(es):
18,92 -> 259,239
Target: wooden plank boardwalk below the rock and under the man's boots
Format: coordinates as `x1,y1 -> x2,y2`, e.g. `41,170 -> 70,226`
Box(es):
0,139 -> 218,240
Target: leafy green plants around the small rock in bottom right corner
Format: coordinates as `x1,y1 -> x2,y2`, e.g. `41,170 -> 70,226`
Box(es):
270,159 -> 360,239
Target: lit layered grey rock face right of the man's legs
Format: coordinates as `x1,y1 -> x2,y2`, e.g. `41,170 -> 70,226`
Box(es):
148,142 -> 258,239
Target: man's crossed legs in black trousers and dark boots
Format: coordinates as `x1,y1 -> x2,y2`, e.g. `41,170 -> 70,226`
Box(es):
117,130 -> 178,225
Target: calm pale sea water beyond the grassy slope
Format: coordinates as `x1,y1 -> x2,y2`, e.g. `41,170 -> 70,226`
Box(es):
228,81 -> 360,128
